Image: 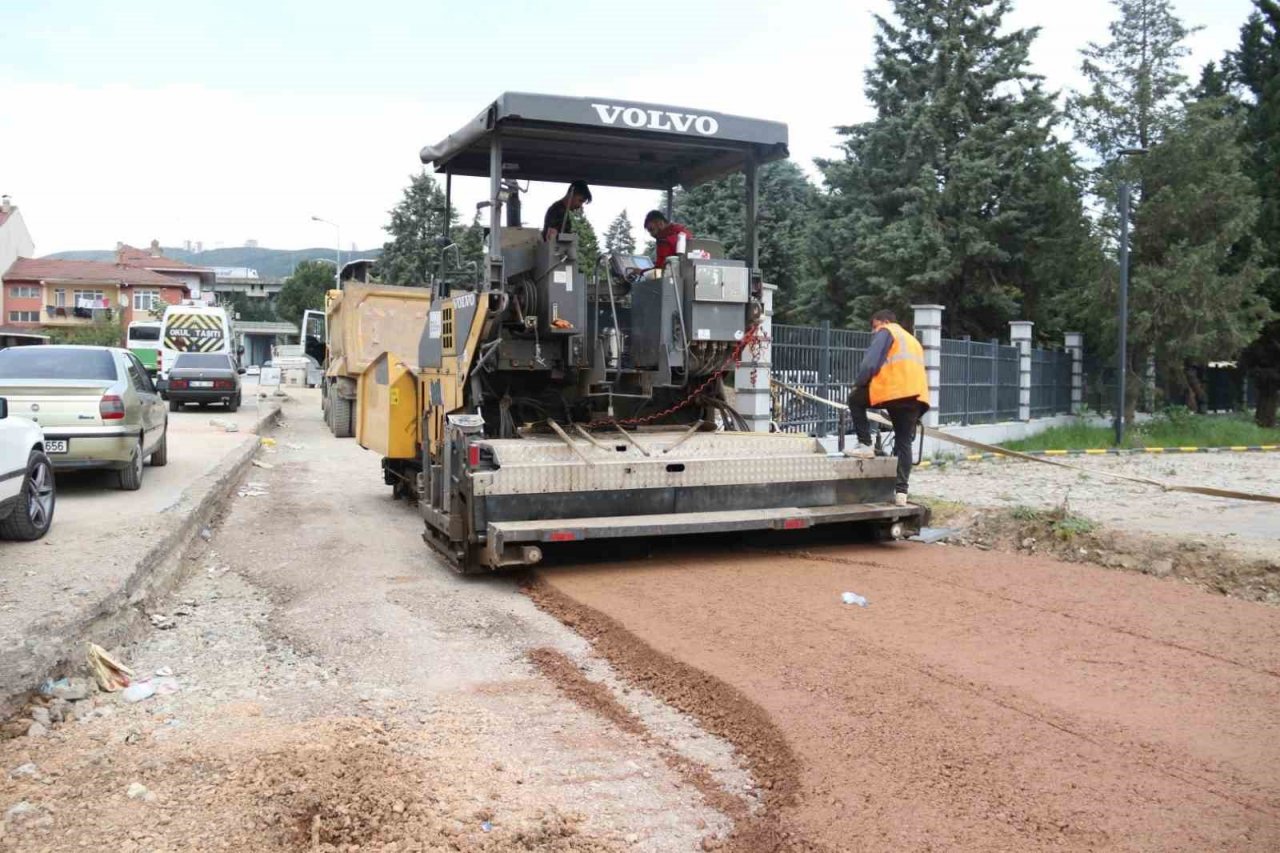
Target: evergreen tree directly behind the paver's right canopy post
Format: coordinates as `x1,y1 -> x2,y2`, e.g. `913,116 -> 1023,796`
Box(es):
672,160 -> 818,323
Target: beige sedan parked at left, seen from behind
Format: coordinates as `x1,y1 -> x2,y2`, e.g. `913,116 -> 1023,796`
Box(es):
0,346 -> 169,491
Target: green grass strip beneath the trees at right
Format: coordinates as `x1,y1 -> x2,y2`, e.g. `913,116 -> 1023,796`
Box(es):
1004,409 -> 1280,451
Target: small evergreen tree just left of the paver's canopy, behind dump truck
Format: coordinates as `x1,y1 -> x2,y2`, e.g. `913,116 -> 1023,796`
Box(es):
378,172 -> 457,287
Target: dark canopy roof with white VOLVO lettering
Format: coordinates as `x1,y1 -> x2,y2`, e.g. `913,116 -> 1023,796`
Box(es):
421,92 -> 787,190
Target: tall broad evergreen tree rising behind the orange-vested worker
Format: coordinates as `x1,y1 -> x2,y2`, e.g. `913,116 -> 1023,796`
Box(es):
805,0 -> 1089,337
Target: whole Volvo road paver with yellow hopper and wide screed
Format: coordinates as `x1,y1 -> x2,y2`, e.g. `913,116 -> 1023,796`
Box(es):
347,92 -> 925,573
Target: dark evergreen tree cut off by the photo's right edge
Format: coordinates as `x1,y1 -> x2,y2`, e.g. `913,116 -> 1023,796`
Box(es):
1231,0 -> 1280,427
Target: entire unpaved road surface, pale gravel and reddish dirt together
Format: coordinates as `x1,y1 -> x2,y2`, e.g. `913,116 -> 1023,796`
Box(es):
0,394 -> 1280,852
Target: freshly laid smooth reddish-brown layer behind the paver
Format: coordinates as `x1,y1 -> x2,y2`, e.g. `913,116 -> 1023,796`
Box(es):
541,544 -> 1280,850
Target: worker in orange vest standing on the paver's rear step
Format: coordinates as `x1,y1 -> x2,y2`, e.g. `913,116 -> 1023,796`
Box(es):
845,311 -> 929,506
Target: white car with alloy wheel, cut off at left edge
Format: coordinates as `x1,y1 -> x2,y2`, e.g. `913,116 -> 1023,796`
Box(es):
0,397 -> 58,540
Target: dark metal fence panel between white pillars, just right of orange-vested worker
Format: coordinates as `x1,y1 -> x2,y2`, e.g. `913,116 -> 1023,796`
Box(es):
937,338 -> 1013,424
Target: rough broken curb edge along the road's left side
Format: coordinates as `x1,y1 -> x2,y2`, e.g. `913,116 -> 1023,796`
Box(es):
0,401 -> 280,717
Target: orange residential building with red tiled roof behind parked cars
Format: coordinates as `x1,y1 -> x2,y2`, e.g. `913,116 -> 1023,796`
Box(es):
3,257 -> 191,329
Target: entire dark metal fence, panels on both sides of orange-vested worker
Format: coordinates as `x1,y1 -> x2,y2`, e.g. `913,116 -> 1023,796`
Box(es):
772,323 -> 1071,435
